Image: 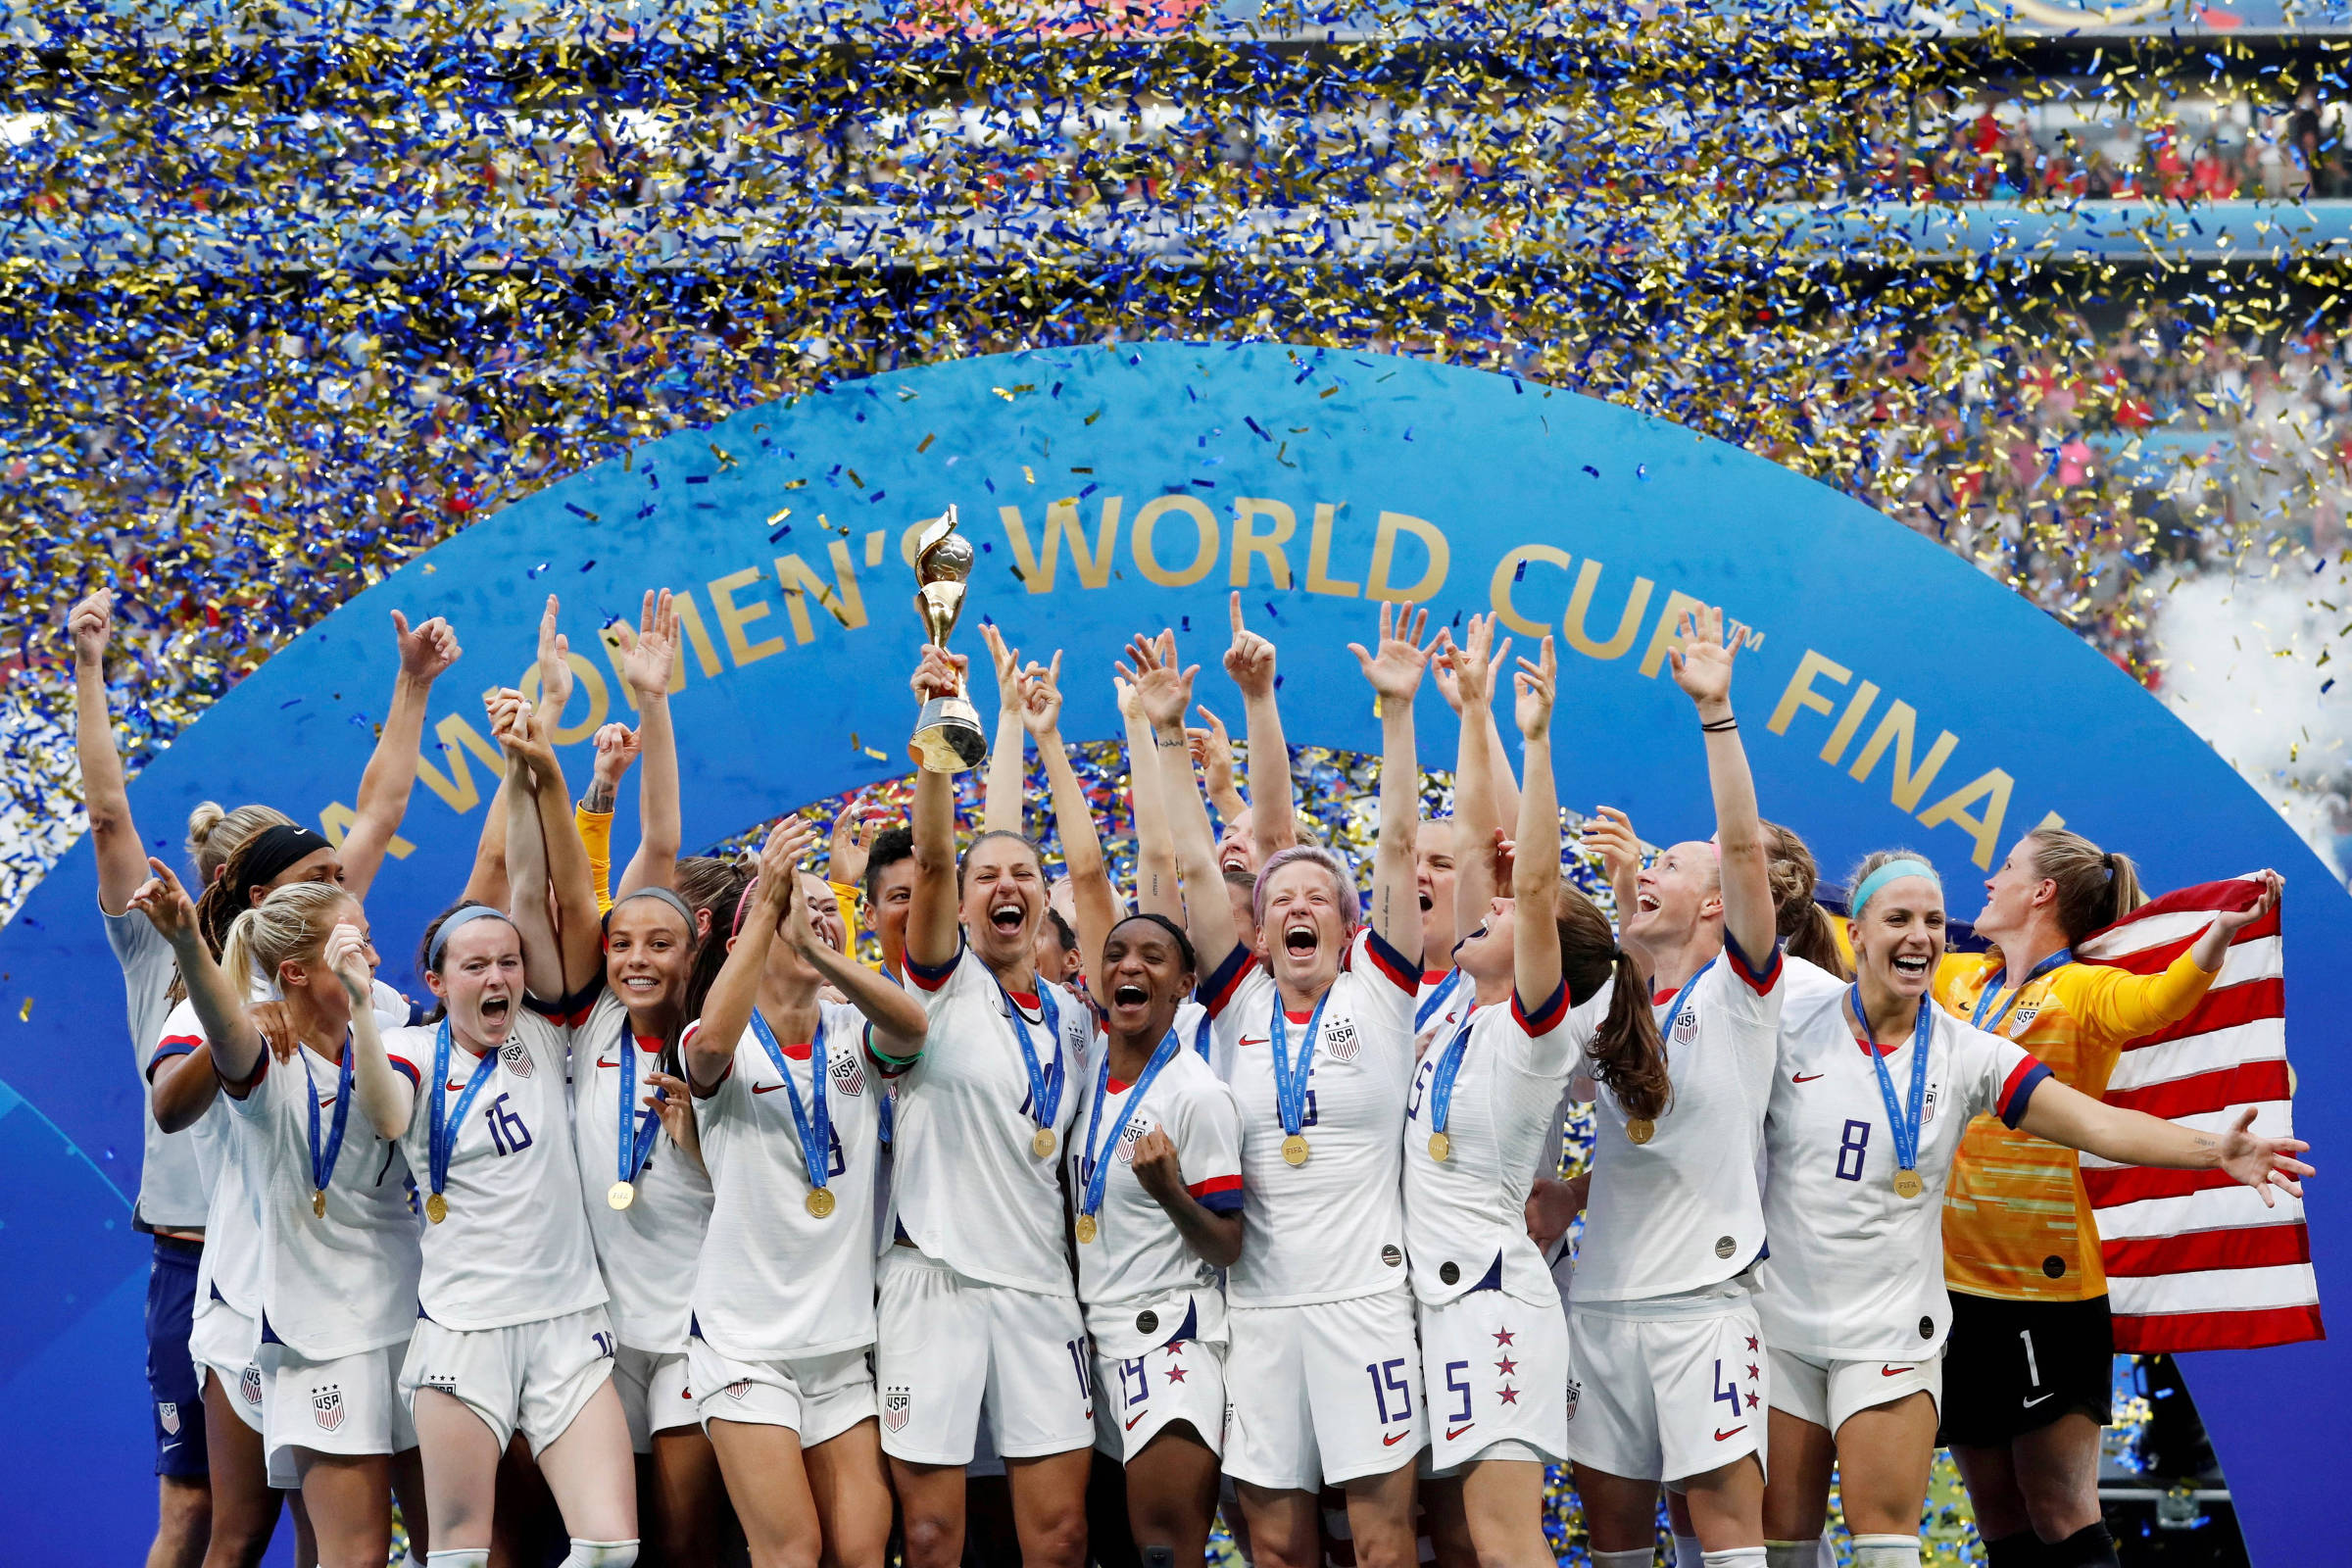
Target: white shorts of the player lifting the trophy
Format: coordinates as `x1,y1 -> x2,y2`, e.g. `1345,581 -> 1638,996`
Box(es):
875,1246 -> 1094,1464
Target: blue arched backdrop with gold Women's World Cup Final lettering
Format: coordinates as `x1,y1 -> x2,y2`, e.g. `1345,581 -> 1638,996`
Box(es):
0,343 -> 2352,1563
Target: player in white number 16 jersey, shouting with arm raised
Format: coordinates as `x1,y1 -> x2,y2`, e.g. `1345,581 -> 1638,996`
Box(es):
358,694 -> 637,1568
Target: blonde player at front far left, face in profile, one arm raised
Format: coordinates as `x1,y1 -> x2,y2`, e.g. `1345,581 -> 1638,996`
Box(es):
131,860 -> 428,1568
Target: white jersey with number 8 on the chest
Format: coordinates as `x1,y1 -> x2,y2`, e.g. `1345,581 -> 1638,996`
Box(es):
1757,987 -> 2048,1361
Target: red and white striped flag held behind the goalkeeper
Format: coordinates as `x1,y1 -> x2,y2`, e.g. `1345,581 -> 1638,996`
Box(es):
2075,879 -> 2327,1354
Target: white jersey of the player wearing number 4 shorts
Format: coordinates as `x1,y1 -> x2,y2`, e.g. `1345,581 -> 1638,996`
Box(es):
1574,936 -> 1786,1304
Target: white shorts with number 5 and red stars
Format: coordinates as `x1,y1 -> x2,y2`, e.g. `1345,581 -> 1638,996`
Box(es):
1421,1291 -> 1569,1476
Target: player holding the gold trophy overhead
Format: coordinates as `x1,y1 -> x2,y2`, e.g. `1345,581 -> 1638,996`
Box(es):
875,647 -> 1094,1568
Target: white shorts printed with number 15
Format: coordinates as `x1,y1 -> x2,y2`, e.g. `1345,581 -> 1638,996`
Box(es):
1225,1281 -> 1428,1493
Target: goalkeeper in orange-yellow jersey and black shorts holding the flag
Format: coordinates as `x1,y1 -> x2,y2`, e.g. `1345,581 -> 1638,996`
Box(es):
1936,827 -> 2279,1568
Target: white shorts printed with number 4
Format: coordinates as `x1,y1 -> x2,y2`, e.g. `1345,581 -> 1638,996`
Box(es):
1569,1296 -> 1774,1481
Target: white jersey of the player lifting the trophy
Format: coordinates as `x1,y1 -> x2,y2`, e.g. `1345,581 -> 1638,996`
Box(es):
892,948 -> 1094,1296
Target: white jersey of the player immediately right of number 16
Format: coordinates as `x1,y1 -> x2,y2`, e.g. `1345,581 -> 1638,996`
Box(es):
571,987 -> 710,1354
